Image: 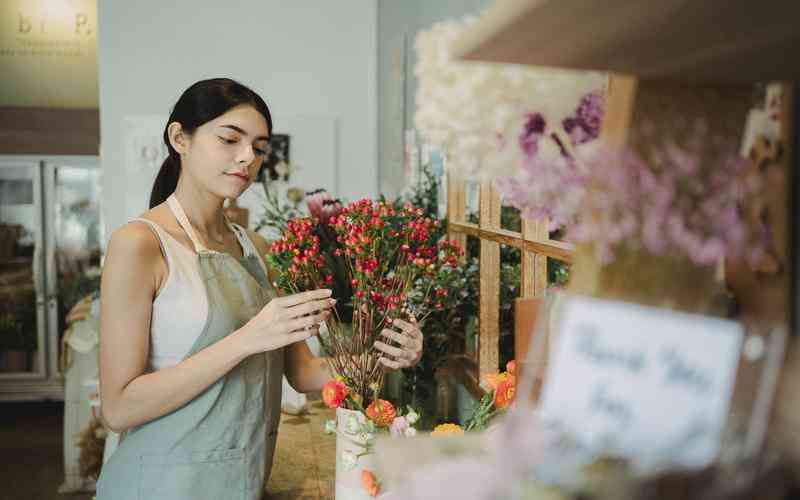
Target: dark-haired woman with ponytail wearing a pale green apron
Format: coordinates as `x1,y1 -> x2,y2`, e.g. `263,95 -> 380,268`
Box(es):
97,79 -> 422,500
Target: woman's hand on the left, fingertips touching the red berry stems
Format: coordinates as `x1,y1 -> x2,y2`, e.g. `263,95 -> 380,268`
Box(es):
236,288 -> 336,355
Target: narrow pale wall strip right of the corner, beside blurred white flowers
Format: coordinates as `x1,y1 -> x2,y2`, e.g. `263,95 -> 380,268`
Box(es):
378,0 -> 491,196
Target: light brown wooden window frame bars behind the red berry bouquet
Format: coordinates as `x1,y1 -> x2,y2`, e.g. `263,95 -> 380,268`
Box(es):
447,173 -> 575,398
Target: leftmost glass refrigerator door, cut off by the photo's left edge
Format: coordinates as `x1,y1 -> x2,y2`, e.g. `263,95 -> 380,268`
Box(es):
0,161 -> 47,379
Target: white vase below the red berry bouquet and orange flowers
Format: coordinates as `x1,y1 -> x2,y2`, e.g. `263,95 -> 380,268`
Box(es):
336,408 -> 375,500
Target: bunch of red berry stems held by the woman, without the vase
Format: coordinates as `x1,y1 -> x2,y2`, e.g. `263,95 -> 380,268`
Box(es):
267,193 -> 463,406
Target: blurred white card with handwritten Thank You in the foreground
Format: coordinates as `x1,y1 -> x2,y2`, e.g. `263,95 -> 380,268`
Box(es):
540,296 -> 743,467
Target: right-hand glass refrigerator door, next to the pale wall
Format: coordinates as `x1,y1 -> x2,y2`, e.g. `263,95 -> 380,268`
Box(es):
45,161 -> 103,374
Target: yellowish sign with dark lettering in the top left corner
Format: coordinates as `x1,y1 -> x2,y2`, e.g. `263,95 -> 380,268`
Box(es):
0,0 -> 98,109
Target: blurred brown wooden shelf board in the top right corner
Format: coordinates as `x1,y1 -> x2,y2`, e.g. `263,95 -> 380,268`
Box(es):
455,0 -> 800,83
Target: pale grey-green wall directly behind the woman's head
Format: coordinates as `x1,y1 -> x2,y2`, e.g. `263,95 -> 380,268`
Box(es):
98,0 -> 378,235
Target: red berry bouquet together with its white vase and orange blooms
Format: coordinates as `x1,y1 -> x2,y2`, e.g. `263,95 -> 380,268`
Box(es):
268,192 -> 463,498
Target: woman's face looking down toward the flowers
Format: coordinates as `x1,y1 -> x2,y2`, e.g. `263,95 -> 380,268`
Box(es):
181,105 -> 270,198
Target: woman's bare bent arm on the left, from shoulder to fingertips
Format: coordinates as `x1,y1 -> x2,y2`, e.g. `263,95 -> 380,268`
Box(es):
100,224 -> 330,432
